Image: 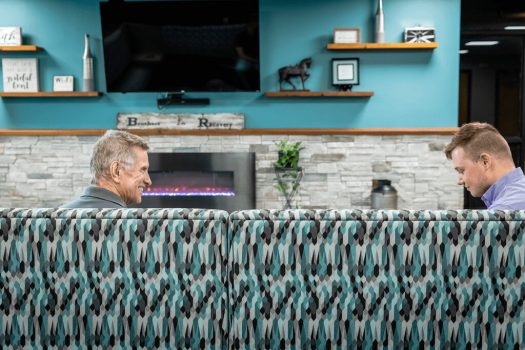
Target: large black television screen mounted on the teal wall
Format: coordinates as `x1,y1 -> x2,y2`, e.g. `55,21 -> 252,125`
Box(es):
100,0 -> 260,92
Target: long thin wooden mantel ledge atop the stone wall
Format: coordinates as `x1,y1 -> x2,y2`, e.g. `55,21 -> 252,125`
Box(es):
0,128 -> 458,137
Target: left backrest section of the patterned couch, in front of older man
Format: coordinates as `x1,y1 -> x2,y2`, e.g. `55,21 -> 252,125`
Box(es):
0,209 -> 228,349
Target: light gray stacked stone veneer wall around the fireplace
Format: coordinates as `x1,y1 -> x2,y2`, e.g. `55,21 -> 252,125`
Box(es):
0,135 -> 463,209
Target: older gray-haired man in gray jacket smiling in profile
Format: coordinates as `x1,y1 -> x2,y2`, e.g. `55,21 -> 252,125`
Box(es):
62,130 -> 151,208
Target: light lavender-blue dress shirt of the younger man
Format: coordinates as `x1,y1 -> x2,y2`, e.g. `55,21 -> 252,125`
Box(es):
481,167 -> 525,210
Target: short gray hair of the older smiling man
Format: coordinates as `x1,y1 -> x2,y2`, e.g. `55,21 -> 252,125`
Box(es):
90,130 -> 149,185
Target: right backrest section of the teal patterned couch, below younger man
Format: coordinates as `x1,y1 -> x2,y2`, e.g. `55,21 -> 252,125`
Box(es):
229,210 -> 525,349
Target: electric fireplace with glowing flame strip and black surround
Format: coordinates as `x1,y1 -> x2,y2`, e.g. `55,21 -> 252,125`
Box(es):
138,152 -> 255,211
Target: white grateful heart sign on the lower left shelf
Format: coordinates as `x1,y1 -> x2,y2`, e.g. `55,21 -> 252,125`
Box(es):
2,58 -> 38,92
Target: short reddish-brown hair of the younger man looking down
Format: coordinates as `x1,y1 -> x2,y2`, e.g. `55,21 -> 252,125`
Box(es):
445,122 -> 512,160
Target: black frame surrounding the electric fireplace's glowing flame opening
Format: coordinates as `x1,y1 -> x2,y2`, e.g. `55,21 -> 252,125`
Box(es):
136,152 -> 255,211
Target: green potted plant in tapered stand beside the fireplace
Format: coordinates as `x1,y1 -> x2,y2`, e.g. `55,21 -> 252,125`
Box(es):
274,141 -> 304,209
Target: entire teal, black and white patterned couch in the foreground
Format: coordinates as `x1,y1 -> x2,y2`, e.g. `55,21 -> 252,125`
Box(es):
0,209 -> 525,349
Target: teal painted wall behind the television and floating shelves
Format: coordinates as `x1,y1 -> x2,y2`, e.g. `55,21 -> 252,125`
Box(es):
0,0 -> 460,129
